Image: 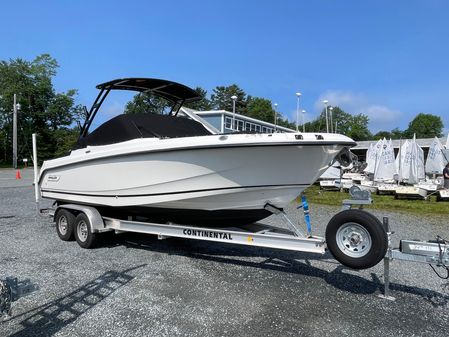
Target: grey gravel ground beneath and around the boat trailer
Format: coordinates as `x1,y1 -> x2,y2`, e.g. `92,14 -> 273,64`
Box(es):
0,170 -> 449,336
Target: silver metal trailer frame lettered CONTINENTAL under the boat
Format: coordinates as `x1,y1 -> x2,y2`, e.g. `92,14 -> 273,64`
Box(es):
41,204 -> 326,255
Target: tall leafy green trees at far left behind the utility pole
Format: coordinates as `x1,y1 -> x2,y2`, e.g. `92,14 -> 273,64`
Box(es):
0,54 -> 82,161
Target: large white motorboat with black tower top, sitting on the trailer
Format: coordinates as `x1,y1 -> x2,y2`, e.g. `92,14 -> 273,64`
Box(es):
39,78 -> 355,225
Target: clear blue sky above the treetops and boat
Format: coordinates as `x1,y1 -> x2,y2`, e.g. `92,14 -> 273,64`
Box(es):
0,0 -> 449,132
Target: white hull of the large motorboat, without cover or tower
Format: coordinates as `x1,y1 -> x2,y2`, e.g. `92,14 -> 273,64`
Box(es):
40,133 -> 352,223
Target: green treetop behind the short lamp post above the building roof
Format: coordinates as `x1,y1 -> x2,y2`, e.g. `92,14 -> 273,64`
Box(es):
211,84 -> 247,115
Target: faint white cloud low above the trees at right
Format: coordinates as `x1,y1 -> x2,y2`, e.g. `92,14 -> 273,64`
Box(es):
314,91 -> 403,132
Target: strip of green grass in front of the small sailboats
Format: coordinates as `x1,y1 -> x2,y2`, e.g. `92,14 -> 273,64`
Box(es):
305,185 -> 449,216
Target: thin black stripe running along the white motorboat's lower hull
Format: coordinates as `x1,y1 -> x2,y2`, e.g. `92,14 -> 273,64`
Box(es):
41,184 -> 310,198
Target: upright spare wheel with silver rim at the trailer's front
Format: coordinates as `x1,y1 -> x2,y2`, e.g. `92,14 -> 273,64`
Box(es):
326,209 -> 388,269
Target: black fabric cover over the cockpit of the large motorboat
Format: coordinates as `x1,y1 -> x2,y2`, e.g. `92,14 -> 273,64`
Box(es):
75,113 -> 211,149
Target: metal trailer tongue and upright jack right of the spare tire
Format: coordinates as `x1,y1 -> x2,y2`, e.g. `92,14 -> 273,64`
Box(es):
379,217 -> 449,301
